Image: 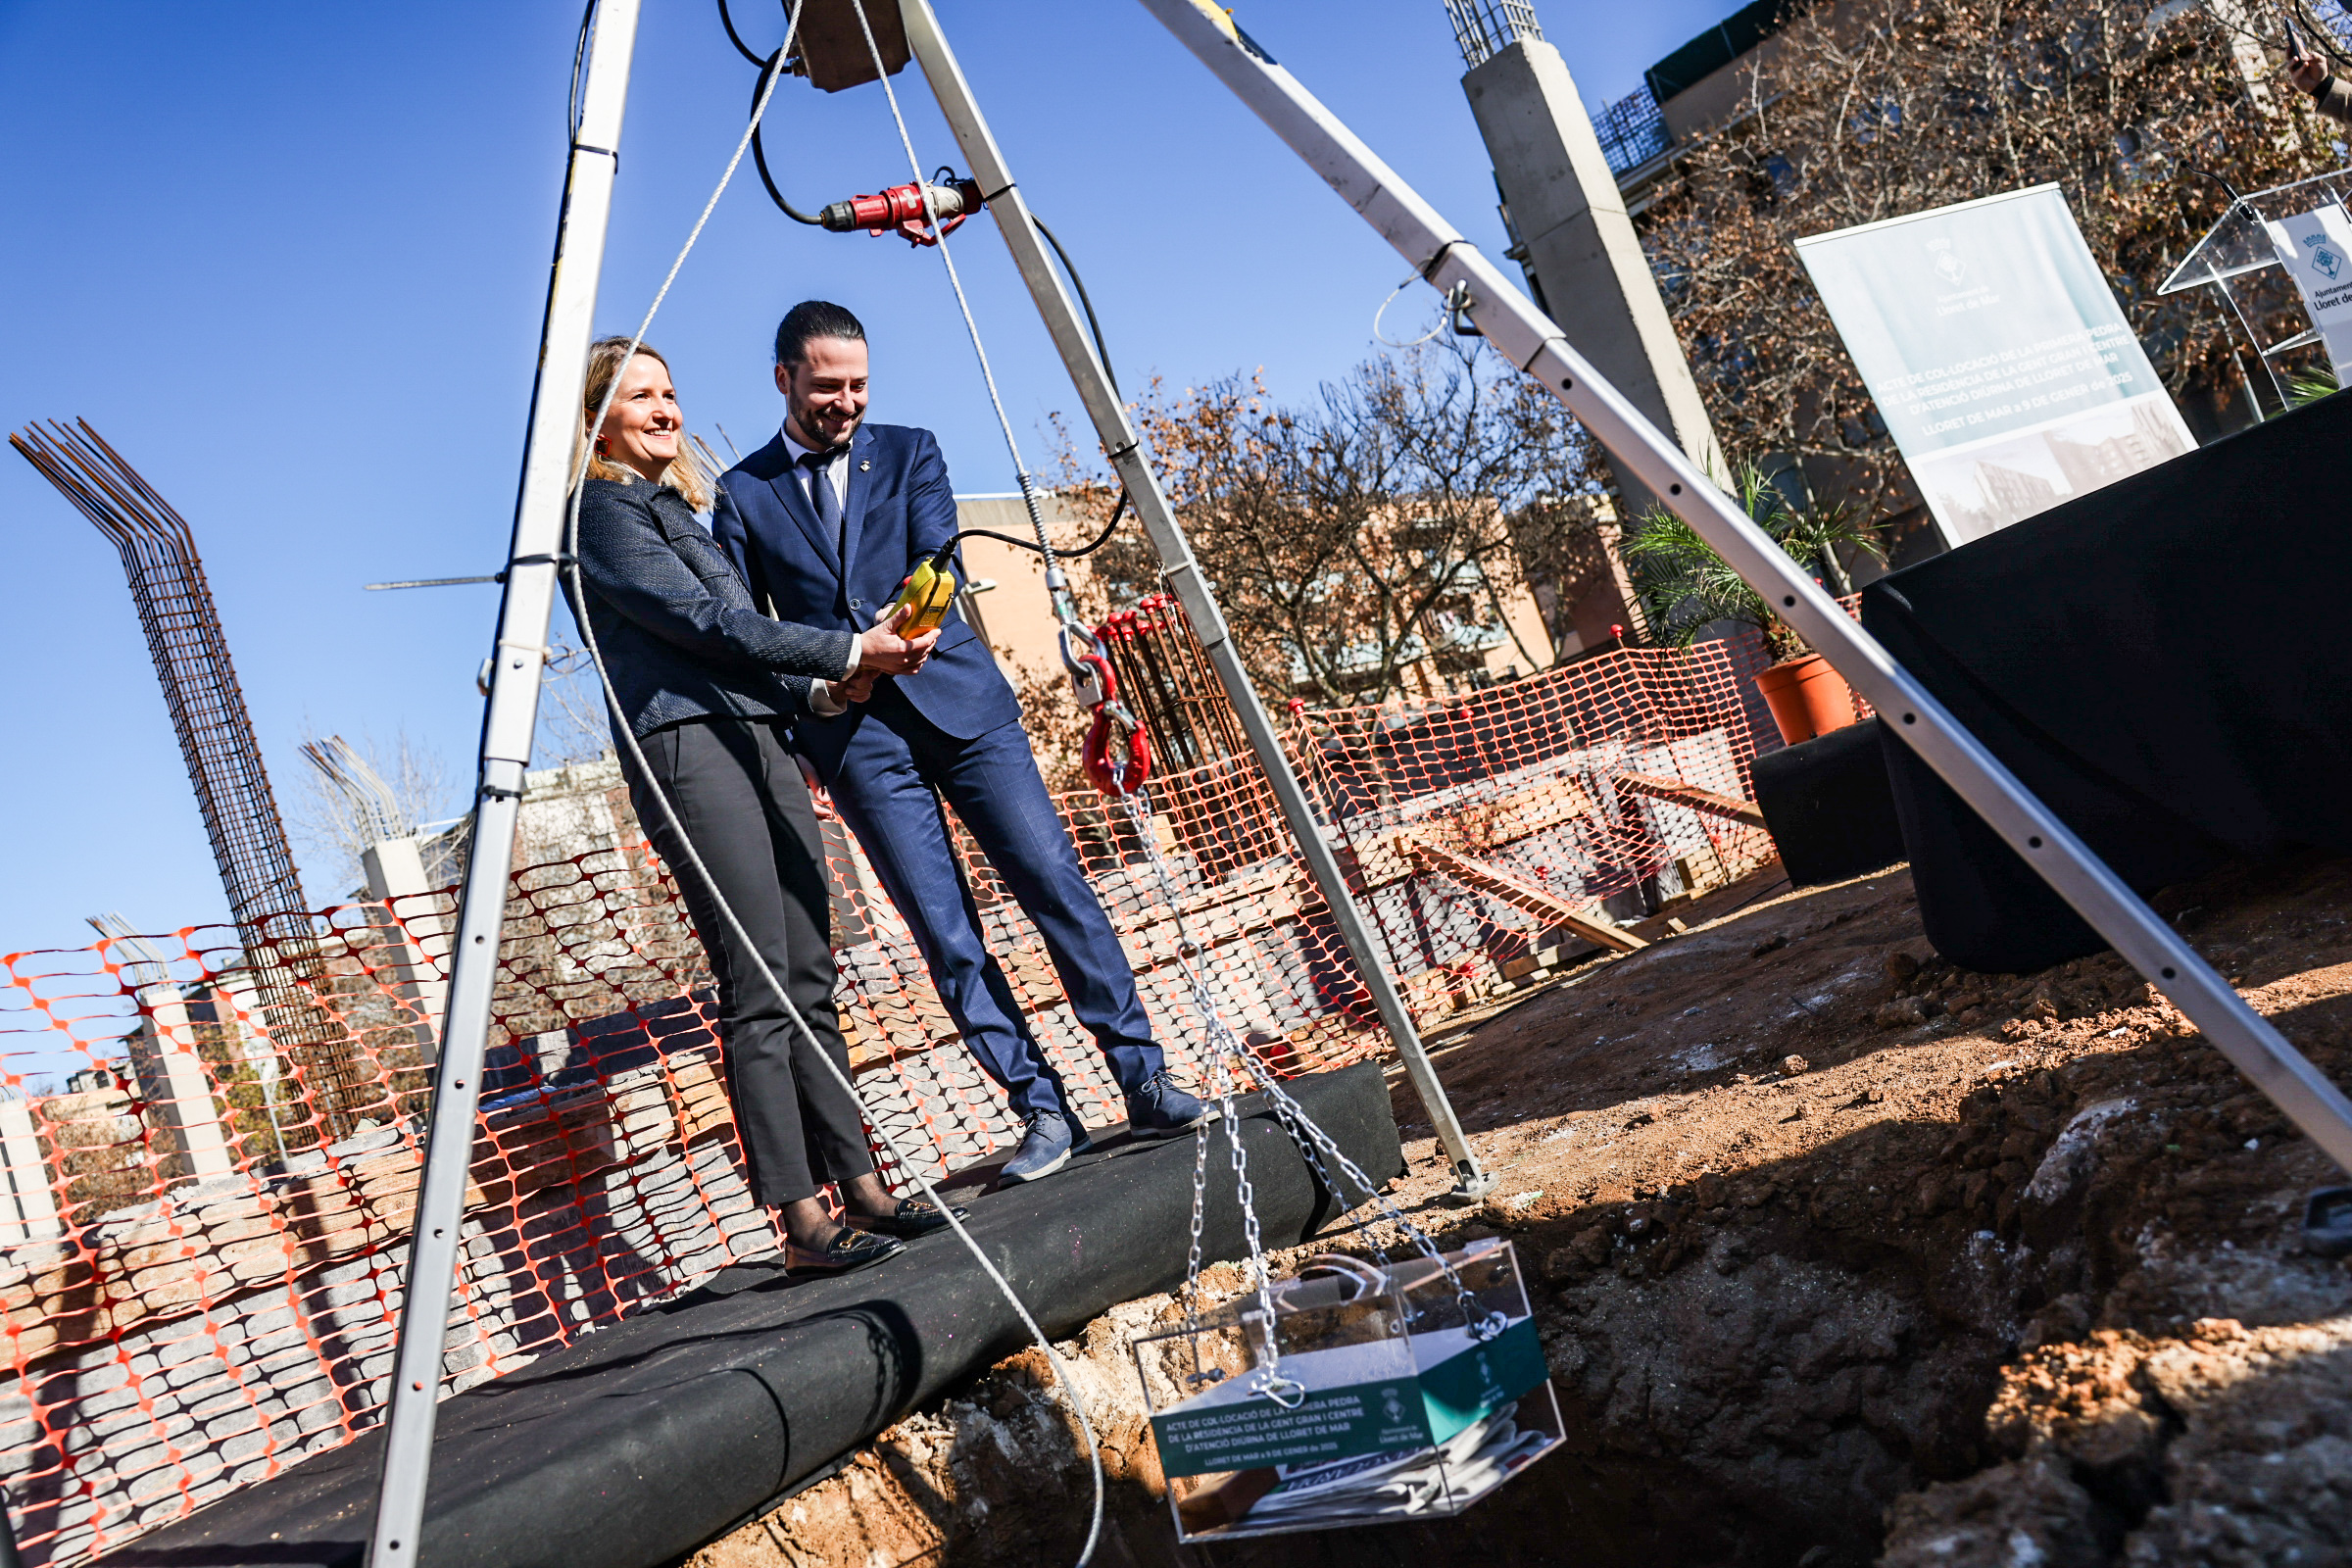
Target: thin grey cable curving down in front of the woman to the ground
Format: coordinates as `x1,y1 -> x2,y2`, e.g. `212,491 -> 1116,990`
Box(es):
545,0 -> 1103,1568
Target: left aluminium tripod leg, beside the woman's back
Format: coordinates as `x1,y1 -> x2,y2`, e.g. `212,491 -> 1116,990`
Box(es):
369,0 -> 637,1568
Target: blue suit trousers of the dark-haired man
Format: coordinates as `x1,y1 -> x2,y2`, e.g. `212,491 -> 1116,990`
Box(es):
833,682 -> 1162,1114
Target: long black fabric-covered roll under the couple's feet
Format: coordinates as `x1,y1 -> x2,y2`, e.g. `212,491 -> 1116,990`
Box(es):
99,1062 -> 1404,1568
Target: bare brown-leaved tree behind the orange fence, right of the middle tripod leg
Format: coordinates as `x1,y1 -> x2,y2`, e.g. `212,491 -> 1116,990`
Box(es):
1063,338 -> 1606,719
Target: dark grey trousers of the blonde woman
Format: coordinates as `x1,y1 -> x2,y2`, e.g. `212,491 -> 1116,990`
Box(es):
623,719 -> 875,1206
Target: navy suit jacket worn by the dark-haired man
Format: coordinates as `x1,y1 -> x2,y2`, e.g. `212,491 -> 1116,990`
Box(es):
712,425 -> 1021,783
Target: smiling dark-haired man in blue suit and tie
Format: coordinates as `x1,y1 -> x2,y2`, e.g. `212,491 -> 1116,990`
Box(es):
719,301 -> 1209,1183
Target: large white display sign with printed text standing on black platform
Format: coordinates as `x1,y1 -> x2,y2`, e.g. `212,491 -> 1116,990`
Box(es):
1797,186 -> 2197,546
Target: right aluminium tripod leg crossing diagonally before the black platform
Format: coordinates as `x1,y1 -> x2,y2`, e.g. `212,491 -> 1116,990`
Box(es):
1143,0 -> 2352,1171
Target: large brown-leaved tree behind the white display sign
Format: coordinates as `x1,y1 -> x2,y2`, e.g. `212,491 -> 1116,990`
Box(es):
1644,0 -> 2342,514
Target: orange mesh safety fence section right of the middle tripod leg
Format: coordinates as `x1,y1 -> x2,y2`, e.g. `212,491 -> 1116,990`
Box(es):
1294,642 -> 1771,1022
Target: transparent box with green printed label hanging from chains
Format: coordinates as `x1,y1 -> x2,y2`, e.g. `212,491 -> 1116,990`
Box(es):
1136,1242 -> 1562,1543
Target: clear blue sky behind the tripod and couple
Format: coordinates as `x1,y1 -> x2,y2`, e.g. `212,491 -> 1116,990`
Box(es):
0,0 -> 1734,953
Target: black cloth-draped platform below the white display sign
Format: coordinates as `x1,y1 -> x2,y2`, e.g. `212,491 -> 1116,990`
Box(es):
1863,397 -> 2352,973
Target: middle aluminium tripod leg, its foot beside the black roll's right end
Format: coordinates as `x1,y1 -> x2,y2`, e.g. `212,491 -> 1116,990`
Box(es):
899,0 -> 1494,1199
